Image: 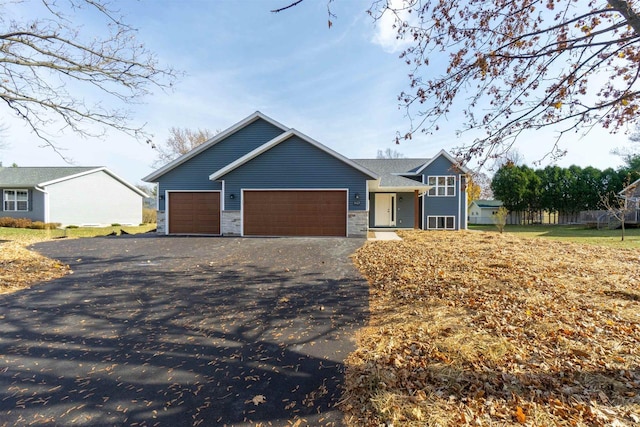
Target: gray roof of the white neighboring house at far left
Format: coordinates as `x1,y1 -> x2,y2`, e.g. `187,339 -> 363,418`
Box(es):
0,166 -> 148,197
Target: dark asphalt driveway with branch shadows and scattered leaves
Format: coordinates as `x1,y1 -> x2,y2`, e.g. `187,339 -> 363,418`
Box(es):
0,236 -> 368,426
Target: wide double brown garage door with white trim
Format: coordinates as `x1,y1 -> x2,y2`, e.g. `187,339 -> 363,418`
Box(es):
243,190 -> 347,236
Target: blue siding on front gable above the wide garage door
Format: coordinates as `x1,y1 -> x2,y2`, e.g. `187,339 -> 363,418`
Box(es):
221,136 -> 368,211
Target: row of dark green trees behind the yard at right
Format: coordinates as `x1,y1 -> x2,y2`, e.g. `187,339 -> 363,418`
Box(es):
491,162 -> 640,224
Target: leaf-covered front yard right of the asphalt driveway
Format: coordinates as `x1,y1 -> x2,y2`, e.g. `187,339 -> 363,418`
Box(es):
342,231 -> 640,426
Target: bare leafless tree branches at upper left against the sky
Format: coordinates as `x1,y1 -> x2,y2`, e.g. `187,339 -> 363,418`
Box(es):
0,0 -> 178,151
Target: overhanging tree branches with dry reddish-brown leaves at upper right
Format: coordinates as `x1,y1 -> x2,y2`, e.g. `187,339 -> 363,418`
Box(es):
369,0 -> 640,163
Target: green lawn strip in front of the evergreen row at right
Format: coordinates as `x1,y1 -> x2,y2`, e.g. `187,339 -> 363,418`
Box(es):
469,225 -> 640,249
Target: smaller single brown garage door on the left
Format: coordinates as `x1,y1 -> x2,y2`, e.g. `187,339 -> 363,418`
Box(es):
169,192 -> 220,234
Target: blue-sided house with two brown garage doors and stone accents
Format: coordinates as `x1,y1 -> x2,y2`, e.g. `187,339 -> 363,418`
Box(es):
143,112 -> 468,236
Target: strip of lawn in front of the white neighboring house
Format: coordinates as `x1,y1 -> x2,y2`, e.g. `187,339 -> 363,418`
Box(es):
0,224 -> 156,242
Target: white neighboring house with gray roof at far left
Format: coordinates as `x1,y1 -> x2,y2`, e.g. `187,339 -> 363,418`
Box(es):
0,167 -> 147,226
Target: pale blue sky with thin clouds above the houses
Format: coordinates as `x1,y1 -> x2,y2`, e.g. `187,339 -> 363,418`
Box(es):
0,0 -> 628,184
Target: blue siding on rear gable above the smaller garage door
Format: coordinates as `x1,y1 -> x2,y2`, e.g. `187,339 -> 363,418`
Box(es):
158,119 -> 284,210
